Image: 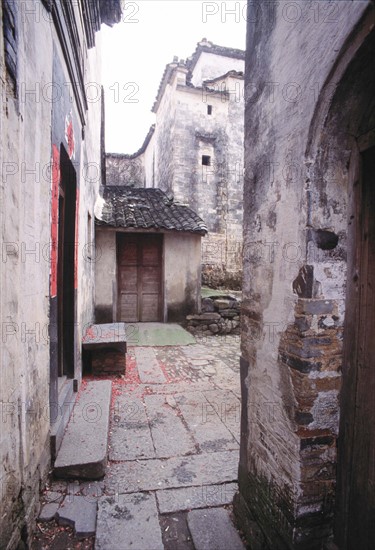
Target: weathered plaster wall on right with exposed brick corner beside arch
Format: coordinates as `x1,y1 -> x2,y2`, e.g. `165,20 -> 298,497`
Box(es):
237,2 -> 369,549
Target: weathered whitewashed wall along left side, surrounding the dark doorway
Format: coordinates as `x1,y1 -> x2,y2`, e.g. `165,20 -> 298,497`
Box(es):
0,1 -> 111,550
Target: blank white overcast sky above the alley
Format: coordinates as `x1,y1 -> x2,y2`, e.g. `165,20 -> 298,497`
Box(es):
102,0 -> 246,153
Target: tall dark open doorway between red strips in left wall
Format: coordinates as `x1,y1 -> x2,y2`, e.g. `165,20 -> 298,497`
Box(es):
57,147 -> 77,378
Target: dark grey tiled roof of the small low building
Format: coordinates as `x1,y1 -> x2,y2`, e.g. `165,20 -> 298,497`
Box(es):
96,187 -> 207,235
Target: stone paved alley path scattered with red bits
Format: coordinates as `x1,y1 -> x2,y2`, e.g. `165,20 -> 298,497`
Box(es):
39,335 -> 242,550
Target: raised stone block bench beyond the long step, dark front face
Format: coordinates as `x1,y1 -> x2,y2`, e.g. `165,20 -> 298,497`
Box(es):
82,323 -> 126,375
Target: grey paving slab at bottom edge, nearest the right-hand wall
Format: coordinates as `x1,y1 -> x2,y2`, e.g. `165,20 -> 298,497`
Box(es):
188,508 -> 245,550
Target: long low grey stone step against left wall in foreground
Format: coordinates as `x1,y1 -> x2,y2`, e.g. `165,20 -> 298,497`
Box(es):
54,380 -> 112,479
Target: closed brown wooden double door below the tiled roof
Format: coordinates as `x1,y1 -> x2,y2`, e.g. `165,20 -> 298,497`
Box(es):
117,233 -> 162,323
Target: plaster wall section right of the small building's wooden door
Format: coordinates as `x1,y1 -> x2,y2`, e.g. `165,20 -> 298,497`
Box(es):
164,233 -> 201,322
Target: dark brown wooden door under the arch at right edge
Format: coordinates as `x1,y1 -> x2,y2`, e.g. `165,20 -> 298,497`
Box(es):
336,147 -> 375,550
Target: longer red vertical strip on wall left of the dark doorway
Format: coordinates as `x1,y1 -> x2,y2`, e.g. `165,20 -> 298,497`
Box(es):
50,144 -> 61,298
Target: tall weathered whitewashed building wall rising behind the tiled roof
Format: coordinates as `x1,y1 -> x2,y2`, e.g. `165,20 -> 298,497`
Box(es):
151,64 -> 244,288
